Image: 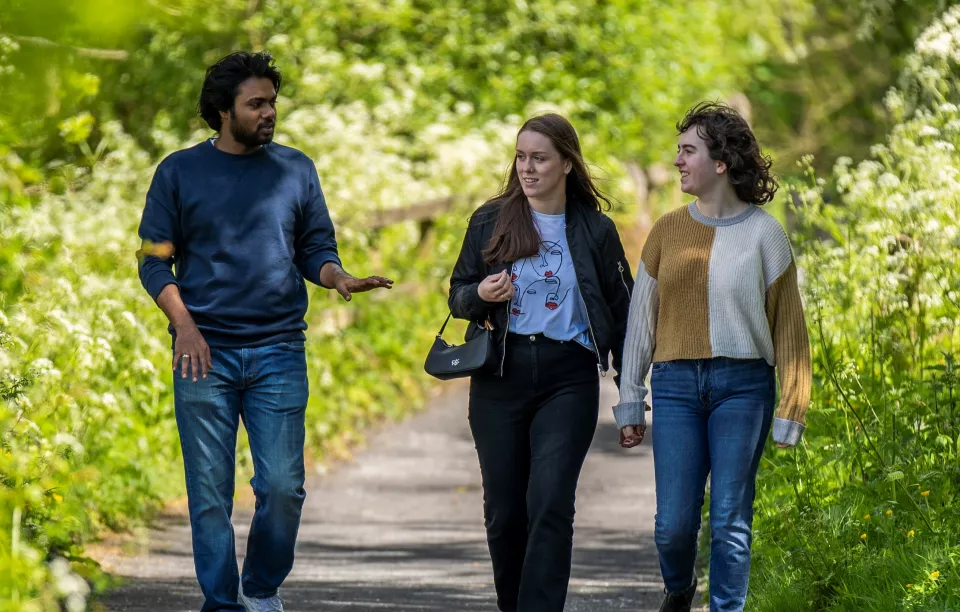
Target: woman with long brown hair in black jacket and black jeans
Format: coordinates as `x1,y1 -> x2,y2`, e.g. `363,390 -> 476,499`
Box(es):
450,114 -> 633,612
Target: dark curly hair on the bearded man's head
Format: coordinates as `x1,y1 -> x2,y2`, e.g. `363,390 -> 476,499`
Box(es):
197,51 -> 282,132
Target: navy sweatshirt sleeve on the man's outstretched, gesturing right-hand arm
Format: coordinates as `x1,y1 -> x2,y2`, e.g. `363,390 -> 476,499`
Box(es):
295,162 -> 340,289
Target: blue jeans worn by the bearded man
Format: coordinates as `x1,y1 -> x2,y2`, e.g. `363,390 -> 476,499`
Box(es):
173,341 -> 308,612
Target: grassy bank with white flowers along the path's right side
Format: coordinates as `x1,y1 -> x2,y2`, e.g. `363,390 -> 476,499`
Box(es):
751,9 -> 960,612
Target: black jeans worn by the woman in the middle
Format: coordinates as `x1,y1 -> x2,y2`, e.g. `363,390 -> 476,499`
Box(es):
470,334 -> 600,612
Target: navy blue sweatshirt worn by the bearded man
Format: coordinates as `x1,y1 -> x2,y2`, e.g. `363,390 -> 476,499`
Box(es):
139,141 -> 340,347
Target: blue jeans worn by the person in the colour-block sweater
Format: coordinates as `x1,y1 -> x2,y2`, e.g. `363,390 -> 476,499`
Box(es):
651,358 -> 776,612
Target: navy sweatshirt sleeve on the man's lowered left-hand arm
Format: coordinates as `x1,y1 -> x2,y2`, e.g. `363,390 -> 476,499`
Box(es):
137,162 -> 182,302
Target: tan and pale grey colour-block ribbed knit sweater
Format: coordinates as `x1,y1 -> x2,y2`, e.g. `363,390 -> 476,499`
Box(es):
614,203 -> 811,445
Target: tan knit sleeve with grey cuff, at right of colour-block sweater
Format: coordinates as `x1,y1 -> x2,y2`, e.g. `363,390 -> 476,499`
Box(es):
766,235 -> 813,446
